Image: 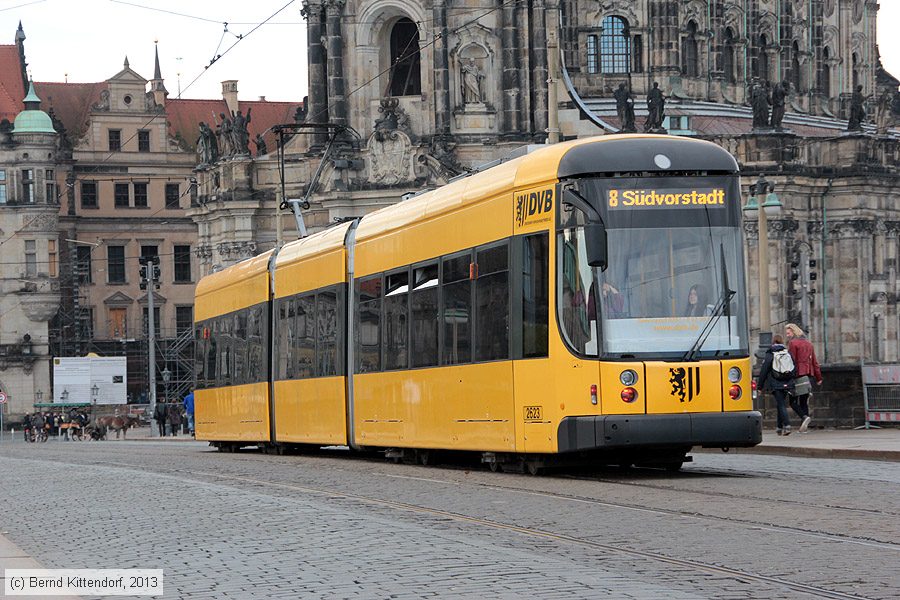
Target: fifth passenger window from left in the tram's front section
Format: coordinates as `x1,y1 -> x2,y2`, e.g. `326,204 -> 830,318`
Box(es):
475,241 -> 509,361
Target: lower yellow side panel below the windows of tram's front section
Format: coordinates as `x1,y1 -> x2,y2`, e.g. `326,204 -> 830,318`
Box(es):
354,361 -> 516,452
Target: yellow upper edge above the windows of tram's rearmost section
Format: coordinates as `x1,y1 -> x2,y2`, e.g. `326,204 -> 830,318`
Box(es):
194,250 -> 273,321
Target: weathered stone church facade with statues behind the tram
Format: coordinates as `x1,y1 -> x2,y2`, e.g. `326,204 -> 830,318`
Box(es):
190,0 -> 900,365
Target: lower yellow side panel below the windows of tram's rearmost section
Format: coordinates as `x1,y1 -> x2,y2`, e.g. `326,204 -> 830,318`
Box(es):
194,381 -> 269,442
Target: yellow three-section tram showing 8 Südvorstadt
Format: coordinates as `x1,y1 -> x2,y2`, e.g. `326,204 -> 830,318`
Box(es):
195,135 -> 762,470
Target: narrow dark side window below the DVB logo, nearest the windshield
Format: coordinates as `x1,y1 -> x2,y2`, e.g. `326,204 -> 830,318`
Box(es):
522,232 -> 550,358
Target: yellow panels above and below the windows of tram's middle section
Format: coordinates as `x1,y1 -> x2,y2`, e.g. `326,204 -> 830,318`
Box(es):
274,223 -> 350,445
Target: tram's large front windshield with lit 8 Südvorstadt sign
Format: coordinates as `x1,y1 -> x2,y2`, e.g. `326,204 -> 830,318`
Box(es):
558,177 -> 749,359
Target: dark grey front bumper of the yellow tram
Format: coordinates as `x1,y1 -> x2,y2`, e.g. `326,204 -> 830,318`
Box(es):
557,410 -> 762,452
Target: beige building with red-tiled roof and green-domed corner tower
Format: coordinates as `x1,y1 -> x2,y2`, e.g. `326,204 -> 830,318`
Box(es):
0,25 -> 298,415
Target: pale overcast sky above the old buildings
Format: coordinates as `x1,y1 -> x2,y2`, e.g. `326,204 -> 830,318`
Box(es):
0,0 -> 900,101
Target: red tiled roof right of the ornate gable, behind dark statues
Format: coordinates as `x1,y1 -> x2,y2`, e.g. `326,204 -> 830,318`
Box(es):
166,99 -> 300,154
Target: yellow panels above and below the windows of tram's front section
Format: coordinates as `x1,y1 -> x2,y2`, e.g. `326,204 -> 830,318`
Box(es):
354,159 -> 521,451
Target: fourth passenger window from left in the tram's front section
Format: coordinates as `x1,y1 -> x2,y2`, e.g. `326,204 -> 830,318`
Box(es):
441,251 -> 472,365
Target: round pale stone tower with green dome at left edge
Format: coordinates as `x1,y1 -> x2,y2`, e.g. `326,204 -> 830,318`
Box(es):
0,30 -> 70,414
